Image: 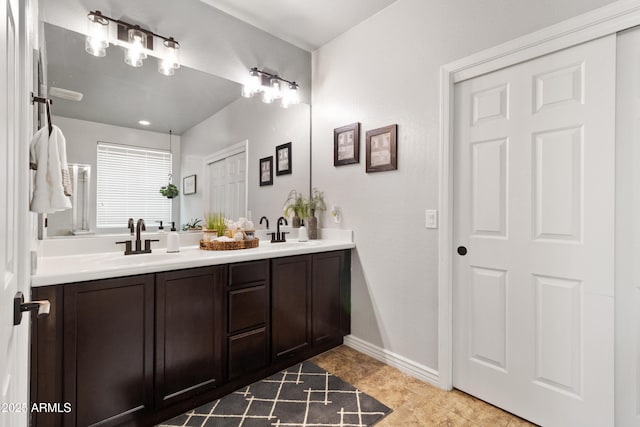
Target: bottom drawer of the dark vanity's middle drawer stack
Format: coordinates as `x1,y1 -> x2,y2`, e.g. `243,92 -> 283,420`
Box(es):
228,328 -> 268,380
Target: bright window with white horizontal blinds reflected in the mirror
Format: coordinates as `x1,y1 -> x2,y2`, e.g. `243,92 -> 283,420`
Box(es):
96,142 -> 171,228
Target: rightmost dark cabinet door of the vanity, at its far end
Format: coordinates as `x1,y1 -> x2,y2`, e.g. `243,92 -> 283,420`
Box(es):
311,252 -> 344,345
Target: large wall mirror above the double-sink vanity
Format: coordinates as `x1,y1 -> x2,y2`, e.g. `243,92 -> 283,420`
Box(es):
40,23 -> 310,237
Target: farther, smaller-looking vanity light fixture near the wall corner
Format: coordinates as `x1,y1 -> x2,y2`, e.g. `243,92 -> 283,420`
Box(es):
242,67 -> 300,108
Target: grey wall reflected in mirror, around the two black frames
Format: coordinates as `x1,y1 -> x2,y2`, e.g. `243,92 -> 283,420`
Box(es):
180,98 -> 311,227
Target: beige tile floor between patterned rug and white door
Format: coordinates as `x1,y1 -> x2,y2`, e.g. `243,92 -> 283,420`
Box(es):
311,345 -> 534,427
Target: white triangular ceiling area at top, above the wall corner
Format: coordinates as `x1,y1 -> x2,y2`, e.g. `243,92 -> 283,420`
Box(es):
200,0 -> 396,51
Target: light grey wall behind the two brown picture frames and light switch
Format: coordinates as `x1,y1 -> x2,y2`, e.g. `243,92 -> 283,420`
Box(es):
312,0 -> 611,370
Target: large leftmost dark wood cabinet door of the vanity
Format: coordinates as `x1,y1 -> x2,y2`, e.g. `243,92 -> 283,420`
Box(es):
63,274 -> 154,426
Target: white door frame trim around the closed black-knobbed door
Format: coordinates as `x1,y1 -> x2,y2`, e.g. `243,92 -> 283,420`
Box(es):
438,0 -> 640,390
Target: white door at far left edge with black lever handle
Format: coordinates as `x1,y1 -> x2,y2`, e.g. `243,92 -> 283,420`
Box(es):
0,0 -> 29,427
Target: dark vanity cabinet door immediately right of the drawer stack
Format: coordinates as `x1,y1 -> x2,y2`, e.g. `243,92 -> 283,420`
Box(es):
271,255 -> 311,360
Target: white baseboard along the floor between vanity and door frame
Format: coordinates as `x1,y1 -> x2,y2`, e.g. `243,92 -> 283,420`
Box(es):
344,335 -> 440,387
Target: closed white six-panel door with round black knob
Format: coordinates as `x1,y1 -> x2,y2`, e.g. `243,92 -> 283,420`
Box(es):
453,36 -> 615,427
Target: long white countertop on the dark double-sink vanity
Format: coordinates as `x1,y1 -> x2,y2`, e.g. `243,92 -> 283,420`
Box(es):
31,239 -> 355,287
